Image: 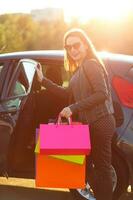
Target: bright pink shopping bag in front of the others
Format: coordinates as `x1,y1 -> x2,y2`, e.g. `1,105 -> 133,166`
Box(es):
40,117 -> 91,155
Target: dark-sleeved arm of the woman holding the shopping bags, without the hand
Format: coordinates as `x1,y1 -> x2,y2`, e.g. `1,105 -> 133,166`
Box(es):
69,60 -> 108,113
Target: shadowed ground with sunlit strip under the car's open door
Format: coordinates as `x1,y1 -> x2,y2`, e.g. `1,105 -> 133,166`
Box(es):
0,178 -> 72,200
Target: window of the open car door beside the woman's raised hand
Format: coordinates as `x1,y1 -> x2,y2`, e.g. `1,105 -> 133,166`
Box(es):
1,60 -> 37,111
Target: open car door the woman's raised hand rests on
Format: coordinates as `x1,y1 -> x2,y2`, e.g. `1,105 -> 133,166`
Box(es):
0,59 -> 38,176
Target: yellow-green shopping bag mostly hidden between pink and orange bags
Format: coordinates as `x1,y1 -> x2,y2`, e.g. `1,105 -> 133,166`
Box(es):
34,129 -> 85,164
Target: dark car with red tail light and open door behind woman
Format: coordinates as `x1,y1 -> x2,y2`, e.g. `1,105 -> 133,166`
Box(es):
0,50 -> 133,200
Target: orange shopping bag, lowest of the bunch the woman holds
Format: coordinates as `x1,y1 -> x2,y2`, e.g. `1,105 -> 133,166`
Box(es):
35,154 -> 86,189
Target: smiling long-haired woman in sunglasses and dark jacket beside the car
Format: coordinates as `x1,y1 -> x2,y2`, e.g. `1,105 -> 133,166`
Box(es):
37,29 -> 115,200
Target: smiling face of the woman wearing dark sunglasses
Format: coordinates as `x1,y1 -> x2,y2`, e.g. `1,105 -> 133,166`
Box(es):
65,36 -> 87,62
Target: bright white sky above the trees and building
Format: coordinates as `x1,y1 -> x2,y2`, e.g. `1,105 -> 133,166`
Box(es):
0,0 -> 133,21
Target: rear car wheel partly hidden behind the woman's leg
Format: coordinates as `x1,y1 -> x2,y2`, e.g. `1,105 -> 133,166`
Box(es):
70,153 -> 128,200
